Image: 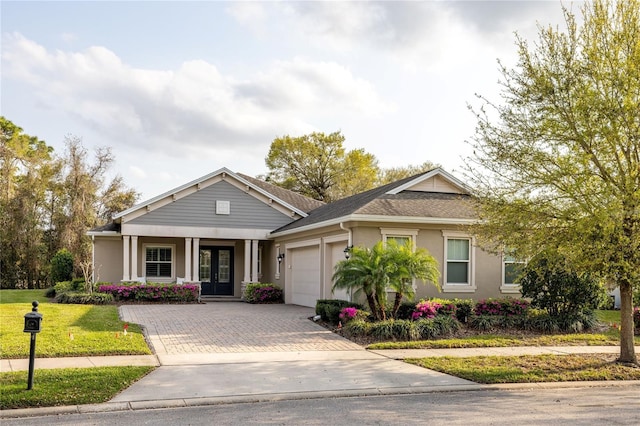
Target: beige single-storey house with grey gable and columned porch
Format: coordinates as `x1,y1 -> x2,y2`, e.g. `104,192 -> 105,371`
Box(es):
89,168 -> 519,306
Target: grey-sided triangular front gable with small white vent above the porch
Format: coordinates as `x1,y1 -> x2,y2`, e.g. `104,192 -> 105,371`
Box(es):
127,180 -> 293,229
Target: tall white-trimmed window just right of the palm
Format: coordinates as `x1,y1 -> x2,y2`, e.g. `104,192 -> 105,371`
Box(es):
442,231 -> 476,292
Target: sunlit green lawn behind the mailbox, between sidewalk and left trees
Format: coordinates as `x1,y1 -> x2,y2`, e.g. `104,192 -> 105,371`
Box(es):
0,290 -> 151,359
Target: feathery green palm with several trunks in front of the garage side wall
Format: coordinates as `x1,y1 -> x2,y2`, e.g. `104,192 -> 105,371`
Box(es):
332,240 -> 439,320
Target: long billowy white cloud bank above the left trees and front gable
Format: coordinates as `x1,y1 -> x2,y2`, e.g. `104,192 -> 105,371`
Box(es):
3,34 -> 392,156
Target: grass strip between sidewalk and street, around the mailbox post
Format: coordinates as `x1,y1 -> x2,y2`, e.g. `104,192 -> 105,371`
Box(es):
0,367 -> 154,410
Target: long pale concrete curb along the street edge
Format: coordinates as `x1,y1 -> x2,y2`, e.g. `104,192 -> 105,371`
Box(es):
0,380 -> 640,419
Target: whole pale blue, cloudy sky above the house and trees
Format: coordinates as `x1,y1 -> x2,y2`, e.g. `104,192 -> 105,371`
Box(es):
0,0 -> 579,200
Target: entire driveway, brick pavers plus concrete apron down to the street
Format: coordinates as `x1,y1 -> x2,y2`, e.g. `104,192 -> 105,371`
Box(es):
111,302 -> 477,402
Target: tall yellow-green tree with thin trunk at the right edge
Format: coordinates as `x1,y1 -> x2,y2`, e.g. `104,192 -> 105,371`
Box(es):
467,0 -> 640,363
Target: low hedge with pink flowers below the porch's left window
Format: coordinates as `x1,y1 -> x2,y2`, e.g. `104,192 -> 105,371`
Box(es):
98,284 -> 200,302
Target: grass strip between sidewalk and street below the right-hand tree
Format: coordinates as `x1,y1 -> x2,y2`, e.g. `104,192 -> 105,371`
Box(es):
405,354 -> 640,384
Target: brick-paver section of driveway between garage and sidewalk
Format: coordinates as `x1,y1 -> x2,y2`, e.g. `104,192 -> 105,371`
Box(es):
120,302 -> 362,355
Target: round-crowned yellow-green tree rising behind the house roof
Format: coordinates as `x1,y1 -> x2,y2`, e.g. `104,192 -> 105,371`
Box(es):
265,132 -> 378,202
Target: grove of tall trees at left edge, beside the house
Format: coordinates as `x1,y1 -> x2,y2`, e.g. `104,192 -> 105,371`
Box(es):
0,117 -> 137,288
